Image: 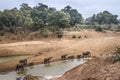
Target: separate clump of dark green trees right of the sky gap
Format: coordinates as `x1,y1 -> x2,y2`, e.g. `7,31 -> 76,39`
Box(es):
86,11 -> 119,26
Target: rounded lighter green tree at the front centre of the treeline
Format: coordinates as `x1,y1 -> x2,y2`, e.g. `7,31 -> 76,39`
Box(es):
47,11 -> 70,28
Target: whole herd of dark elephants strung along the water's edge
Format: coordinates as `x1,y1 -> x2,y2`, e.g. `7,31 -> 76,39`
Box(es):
16,51 -> 91,72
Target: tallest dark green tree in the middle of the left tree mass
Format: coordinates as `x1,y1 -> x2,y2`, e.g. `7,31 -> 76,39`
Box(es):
31,3 -> 51,30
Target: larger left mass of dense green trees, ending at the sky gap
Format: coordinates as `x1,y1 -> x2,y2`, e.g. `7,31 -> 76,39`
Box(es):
0,3 -> 83,33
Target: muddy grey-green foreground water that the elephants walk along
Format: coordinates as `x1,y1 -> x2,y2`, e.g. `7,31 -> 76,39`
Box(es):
0,59 -> 85,80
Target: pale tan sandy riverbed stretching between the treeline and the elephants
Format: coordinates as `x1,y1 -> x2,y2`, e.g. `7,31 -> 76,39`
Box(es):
0,30 -> 120,71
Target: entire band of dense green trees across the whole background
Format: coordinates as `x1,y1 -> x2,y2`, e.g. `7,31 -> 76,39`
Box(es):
0,3 -> 120,35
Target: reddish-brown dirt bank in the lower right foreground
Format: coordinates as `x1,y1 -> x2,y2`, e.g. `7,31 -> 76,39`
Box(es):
52,57 -> 120,80
